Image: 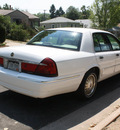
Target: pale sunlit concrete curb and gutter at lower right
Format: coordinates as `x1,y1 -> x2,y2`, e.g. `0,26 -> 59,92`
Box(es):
69,98 -> 120,130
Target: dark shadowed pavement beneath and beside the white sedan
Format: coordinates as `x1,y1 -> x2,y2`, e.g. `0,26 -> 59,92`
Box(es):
0,75 -> 120,129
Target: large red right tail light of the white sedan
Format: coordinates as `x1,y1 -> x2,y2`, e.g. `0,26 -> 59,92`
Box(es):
21,58 -> 58,77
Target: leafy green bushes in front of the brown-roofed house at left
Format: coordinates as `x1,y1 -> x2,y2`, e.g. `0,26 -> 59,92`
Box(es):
0,15 -> 36,43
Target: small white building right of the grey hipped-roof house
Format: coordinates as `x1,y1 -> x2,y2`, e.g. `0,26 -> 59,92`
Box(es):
75,19 -> 92,28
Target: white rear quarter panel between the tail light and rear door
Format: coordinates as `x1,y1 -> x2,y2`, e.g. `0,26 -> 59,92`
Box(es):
57,52 -> 98,76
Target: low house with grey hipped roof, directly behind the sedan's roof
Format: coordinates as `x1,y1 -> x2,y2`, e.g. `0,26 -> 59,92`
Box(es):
40,17 -> 80,29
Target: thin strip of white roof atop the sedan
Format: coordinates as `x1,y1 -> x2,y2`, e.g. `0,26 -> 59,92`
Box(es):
47,27 -> 109,33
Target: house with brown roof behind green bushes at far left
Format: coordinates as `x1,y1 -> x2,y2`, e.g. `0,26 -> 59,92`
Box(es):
0,9 -> 40,28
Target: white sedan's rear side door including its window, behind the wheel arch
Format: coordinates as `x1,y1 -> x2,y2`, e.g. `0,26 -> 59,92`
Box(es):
93,33 -> 116,79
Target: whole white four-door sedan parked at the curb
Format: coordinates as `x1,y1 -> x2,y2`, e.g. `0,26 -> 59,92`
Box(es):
0,28 -> 120,98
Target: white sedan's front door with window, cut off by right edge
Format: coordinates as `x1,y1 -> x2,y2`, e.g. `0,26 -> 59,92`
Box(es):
106,34 -> 120,73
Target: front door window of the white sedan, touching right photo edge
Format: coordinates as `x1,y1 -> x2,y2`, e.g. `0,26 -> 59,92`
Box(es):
107,34 -> 120,50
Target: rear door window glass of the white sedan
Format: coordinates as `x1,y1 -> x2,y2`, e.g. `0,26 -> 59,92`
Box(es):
93,33 -> 111,52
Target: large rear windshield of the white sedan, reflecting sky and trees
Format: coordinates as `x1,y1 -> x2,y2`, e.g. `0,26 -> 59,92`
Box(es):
27,30 -> 82,50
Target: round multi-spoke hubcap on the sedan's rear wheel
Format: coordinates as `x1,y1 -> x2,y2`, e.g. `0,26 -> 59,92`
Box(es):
84,74 -> 97,97
